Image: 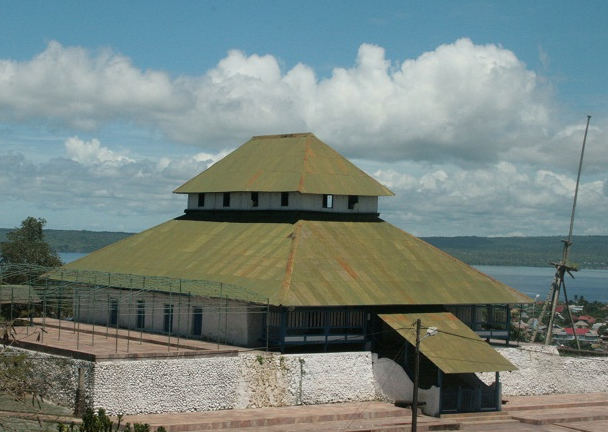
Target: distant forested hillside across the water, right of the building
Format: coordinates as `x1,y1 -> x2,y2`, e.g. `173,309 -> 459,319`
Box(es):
422,236 -> 608,269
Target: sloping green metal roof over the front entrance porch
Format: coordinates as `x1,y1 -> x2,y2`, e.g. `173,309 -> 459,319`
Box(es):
379,312 -> 517,373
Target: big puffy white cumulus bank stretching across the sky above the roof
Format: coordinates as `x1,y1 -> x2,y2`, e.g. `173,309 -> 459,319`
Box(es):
0,38 -> 608,171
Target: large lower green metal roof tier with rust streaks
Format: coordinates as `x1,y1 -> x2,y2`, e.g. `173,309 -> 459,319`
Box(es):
58,220 -> 531,306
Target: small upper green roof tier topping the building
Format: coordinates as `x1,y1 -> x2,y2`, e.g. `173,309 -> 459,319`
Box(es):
174,133 -> 394,196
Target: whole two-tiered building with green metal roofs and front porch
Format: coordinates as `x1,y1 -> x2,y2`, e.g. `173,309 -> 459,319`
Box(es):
53,133 -> 531,412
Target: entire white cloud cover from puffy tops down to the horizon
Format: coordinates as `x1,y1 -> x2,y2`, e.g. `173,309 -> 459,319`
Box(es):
0,39 -> 608,235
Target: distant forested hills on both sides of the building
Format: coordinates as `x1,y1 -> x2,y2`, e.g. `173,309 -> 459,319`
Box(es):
0,228 -> 608,269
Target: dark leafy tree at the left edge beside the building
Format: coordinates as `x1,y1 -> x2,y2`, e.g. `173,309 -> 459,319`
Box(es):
0,216 -> 63,267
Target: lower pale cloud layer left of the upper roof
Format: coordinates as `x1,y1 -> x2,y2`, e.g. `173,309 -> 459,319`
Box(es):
0,137 -> 216,230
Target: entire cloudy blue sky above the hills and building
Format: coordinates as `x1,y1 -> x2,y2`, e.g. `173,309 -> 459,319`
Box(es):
0,1 -> 608,236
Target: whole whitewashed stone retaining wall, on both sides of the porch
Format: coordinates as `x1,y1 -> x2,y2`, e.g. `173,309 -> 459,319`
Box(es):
22,346 -> 608,414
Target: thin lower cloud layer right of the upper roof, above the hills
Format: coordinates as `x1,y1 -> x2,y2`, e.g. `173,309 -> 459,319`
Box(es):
375,162 -> 608,236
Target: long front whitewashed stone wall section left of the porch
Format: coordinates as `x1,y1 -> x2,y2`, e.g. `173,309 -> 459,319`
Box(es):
91,352 -> 376,414
